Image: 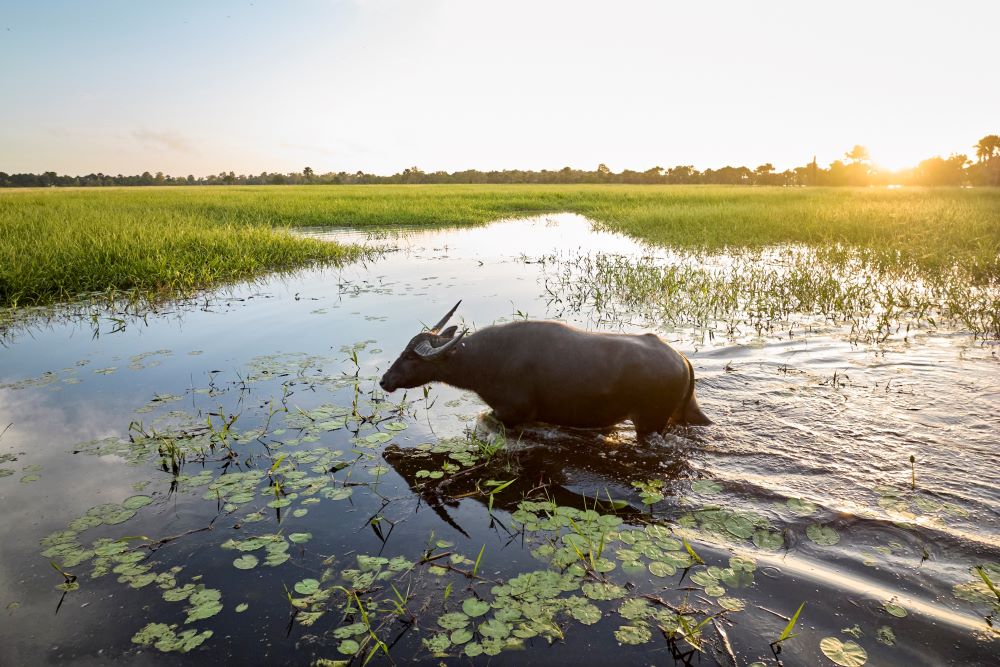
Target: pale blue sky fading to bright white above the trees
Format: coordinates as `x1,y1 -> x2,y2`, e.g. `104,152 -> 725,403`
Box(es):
0,0 -> 1000,176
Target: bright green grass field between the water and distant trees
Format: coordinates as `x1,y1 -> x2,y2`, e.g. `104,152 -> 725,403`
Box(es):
0,186 -> 1000,306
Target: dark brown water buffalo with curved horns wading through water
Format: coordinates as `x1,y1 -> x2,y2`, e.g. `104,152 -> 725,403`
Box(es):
379,301 -> 711,436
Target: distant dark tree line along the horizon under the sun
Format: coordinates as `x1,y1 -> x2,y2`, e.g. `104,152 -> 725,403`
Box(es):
0,134 -> 1000,188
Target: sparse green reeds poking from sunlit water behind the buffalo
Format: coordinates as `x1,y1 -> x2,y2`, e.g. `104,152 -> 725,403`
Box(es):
540,246 -> 1000,343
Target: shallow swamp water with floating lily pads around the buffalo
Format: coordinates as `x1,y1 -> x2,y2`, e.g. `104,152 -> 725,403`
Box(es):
0,215 -> 1000,665
